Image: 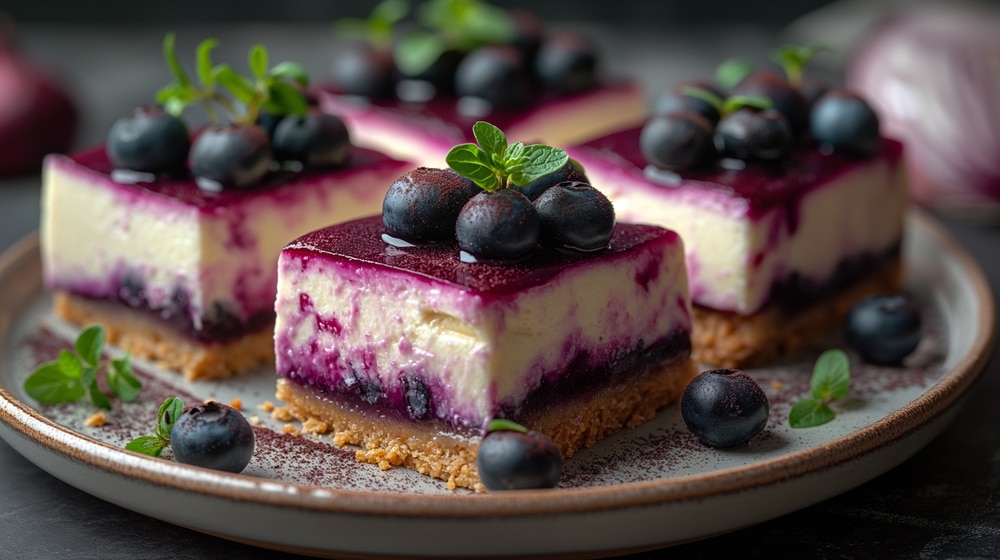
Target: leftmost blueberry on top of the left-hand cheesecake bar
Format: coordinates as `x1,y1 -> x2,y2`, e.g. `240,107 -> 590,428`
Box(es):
107,105 -> 191,173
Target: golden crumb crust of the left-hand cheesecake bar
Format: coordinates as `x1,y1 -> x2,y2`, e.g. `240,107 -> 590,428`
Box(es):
53,292 -> 274,381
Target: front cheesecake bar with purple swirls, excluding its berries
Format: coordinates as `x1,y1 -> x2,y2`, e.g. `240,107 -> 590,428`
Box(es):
275,216 -> 695,490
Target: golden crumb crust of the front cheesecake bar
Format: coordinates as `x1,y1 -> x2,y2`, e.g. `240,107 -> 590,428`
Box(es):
276,357 -> 697,492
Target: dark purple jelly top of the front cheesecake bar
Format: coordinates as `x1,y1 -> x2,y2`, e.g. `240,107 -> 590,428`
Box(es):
284,216 -> 680,297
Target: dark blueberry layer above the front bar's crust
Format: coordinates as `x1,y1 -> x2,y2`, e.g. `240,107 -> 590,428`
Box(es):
278,331 -> 691,437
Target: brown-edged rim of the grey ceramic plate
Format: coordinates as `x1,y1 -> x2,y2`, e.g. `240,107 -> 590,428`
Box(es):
0,209 -> 995,528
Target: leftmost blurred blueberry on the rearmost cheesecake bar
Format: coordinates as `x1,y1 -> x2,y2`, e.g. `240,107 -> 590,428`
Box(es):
331,40 -> 396,99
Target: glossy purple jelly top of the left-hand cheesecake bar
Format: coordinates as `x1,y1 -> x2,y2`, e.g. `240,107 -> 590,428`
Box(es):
71,146 -> 399,212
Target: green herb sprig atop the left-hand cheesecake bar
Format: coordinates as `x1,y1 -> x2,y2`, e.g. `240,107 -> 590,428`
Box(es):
156,33 -> 309,124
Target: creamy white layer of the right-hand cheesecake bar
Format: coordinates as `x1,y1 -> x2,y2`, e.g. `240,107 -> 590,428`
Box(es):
570,150 -> 907,314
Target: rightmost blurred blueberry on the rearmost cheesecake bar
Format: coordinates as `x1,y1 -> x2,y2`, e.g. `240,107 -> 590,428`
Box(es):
535,30 -> 598,95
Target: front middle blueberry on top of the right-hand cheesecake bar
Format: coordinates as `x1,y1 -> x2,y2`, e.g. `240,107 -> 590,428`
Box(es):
714,107 -> 792,161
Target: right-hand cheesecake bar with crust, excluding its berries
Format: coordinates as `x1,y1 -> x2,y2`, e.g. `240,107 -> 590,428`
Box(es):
567,127 -> 907,367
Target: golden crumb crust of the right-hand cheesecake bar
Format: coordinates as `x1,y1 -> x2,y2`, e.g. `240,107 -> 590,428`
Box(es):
691,261 -> 903,368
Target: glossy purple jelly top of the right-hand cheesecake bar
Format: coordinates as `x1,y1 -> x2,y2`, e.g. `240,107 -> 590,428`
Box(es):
578,127 -> 903,218
